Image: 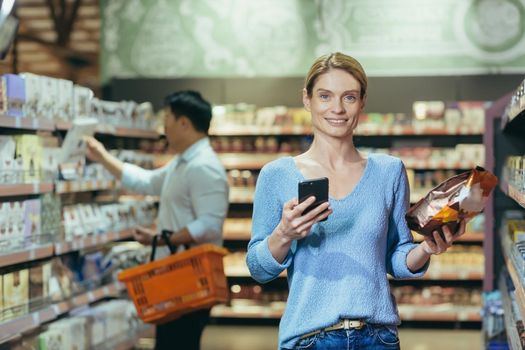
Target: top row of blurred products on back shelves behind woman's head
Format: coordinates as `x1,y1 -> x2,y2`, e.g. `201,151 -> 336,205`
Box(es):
210,101 -> 486,135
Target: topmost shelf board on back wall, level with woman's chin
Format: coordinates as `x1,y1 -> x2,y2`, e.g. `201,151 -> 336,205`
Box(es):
209,124 -> 482,136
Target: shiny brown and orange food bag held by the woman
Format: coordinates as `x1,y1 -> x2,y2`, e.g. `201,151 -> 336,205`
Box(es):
406,166 -> 498,236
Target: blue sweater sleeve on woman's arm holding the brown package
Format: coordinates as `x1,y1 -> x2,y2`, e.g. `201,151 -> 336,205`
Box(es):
386,161 -> 430,279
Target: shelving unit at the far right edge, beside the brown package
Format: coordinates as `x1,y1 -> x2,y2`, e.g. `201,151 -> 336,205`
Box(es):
484,80 -> 525,349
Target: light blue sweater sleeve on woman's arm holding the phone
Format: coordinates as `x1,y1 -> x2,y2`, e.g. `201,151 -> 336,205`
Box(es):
246,167 -> 292,283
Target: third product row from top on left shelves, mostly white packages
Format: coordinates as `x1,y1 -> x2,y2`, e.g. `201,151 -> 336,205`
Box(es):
0,194 -> 156,253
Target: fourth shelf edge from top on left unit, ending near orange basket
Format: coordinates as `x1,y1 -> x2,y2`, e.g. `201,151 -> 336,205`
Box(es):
0,282 -> 124,344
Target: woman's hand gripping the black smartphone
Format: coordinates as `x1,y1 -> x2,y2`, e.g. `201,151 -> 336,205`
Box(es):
274,196 -> 332,242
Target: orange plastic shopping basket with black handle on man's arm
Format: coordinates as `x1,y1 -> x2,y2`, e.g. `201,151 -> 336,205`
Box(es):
118,231 -> 228,324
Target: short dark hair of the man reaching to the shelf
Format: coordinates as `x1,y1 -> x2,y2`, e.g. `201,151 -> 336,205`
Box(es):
164,90 -> 211,134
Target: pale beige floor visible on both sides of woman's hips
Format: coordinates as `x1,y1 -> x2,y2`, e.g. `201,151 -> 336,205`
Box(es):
201,326 -> 482,350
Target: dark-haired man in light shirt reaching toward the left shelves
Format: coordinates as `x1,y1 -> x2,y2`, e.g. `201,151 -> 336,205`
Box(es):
87,91 -> 228,350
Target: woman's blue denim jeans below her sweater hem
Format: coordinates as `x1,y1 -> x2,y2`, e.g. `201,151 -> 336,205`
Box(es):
294,324 -> 400,350
